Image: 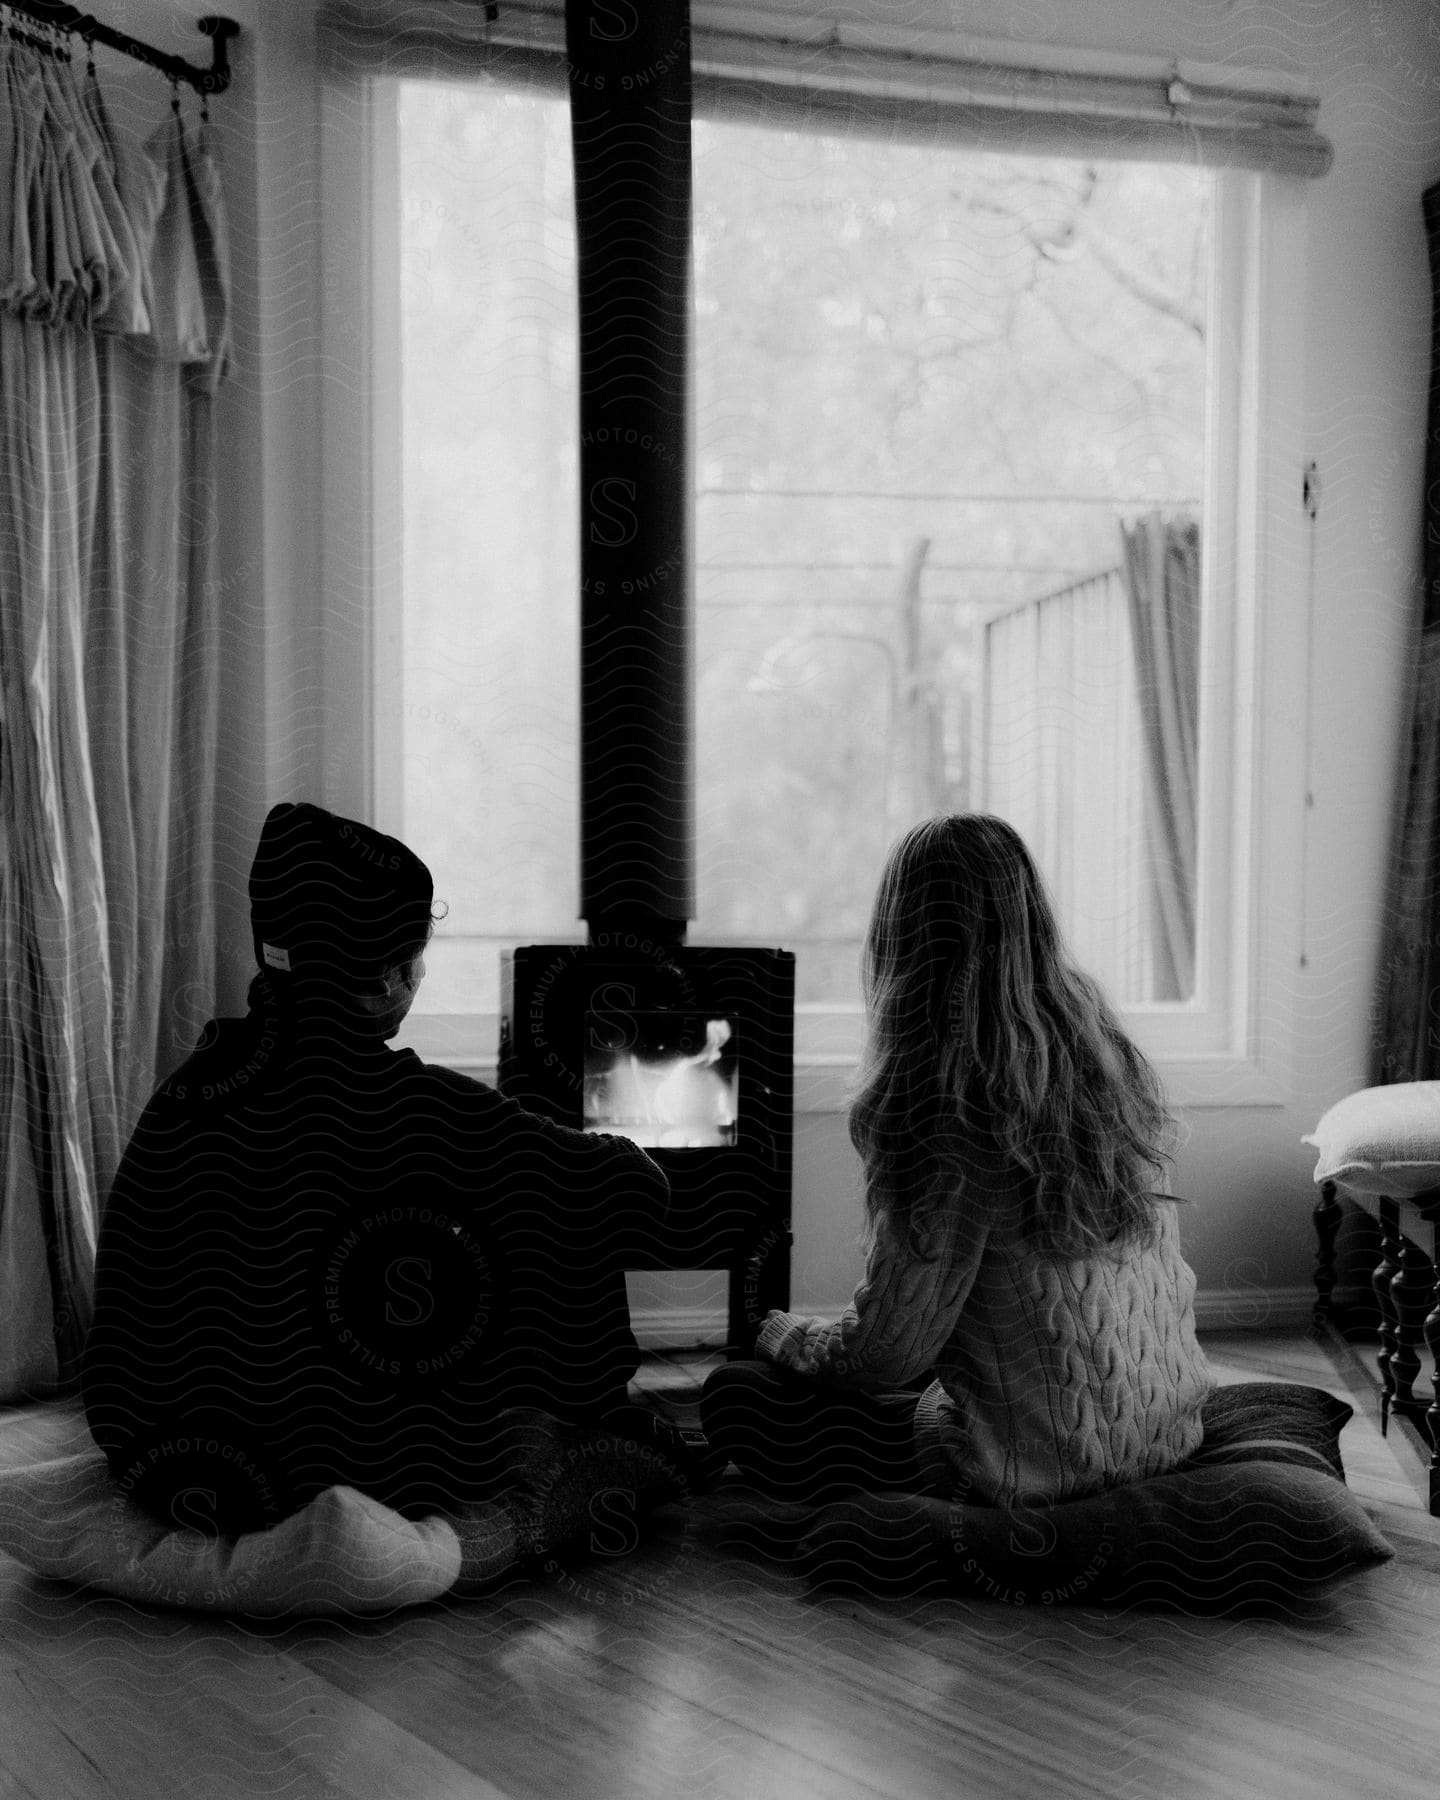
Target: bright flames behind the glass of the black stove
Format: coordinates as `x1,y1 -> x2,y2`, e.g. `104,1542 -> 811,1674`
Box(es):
585,1019 -> 736,1150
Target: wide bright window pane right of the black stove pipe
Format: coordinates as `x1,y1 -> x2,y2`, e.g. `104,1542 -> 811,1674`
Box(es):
695,121 -> 1213,1003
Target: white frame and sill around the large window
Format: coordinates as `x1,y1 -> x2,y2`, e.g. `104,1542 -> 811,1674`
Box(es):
317,76 -> 1309,1112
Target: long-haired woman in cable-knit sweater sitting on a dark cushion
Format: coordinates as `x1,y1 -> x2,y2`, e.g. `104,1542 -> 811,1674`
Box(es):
702,814 -> 1213,1507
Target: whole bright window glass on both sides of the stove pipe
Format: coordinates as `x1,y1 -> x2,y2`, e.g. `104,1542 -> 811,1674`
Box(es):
378,81 -> 1224,1051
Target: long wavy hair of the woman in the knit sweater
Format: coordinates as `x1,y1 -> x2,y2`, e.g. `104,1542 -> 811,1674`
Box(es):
850,814 -> 1174,1256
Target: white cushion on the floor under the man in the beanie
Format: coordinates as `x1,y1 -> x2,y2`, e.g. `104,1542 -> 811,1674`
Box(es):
0,1451 -> 461,1616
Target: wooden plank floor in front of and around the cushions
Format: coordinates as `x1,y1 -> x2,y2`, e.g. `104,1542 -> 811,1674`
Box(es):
0,1334 -> 1440,1800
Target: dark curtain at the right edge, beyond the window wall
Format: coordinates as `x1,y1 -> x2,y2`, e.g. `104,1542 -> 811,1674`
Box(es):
1370,182 -> 1440,1087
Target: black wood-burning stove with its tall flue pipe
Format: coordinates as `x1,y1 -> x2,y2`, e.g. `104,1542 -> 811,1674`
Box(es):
499,0 -> 796,1354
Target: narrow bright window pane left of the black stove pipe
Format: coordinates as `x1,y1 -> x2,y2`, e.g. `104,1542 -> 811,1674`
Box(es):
400,81 -> 580,1012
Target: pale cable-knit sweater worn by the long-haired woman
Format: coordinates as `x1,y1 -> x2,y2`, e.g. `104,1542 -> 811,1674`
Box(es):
756,1204 -> 1213,1505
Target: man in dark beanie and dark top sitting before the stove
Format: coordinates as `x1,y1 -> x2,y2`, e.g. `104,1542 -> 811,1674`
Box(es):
85,805 -> 668,1530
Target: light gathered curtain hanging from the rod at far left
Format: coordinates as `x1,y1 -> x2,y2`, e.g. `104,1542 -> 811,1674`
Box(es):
0,40 -> 230,1399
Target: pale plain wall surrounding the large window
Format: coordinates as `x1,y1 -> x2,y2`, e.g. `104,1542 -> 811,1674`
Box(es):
199,0 -> 1440,1323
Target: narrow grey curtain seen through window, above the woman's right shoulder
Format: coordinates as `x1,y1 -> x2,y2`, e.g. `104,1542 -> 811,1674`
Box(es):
1120,513 -> 1201,1001
